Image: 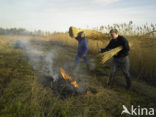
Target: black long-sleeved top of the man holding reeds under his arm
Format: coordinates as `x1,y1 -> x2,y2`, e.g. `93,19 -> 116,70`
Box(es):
101,35 -> 130,58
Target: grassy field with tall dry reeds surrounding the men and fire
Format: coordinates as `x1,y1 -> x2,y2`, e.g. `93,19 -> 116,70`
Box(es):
0,27 -> 156,117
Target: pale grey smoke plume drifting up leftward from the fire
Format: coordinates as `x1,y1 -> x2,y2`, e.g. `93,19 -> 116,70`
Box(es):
14,40 -> 58,81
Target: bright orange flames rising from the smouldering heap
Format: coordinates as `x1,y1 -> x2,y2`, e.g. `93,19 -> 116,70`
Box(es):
60,68 -> 79,87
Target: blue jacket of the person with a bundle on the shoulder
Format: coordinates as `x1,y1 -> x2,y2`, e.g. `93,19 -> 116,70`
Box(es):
75,37 -> 88,57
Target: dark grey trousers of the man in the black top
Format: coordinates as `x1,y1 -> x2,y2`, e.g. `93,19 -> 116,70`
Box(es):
109,56 -> 131,88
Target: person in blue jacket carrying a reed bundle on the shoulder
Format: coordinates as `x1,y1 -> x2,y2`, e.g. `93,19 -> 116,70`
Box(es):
74,31 -> 89,70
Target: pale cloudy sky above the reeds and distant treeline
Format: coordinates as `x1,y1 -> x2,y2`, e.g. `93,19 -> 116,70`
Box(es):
0,0 -> 156,32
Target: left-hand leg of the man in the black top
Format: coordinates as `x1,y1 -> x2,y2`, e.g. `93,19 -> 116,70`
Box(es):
108,58 -> 118,87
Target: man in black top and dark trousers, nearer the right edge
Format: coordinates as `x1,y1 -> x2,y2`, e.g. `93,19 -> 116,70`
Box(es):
99,29 -> 131,89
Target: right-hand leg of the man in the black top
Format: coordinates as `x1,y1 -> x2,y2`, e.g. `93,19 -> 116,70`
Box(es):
122,56 -> 131,89
